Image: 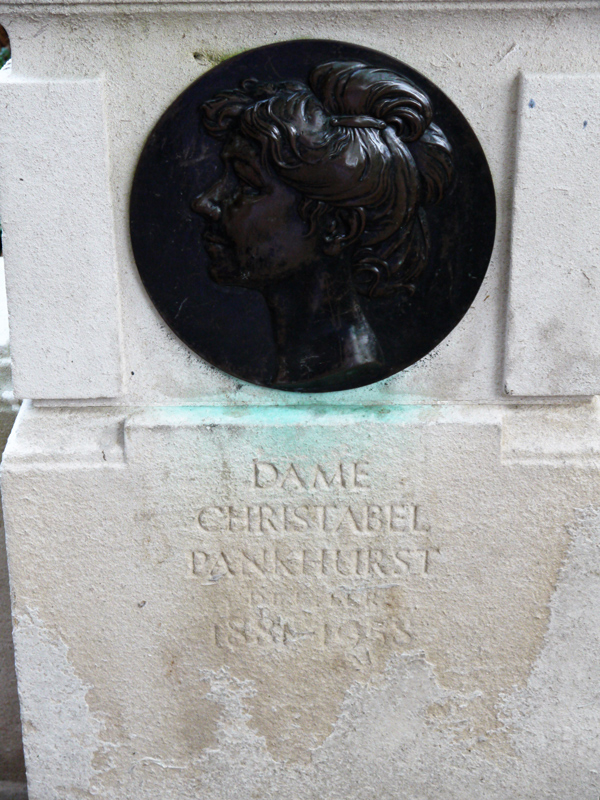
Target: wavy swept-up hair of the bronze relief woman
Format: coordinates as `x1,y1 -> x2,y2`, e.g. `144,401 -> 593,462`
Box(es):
202,61 -> 453,297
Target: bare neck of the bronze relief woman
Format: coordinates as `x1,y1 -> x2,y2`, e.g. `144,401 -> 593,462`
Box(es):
264,264 -> 383,391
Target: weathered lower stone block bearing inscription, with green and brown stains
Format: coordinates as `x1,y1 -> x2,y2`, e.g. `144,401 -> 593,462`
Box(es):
3,403 -> 600,800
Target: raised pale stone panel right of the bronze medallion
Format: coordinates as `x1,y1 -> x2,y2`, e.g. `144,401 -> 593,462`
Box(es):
505,74 -> 600,396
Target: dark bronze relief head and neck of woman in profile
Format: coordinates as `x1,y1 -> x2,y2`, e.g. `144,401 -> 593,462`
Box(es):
193,61 -> 453,390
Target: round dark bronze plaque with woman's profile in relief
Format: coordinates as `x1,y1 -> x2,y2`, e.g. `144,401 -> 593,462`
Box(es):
131,40 -> 495,392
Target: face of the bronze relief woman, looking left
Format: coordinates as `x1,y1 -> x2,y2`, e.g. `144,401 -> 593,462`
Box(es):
192,134 -> 318,289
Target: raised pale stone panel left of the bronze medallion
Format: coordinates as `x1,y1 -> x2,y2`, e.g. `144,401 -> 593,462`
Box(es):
0,73 -> 122,398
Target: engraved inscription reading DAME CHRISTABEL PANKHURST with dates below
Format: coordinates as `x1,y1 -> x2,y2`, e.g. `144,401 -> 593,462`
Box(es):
187,456 -> 439,669
